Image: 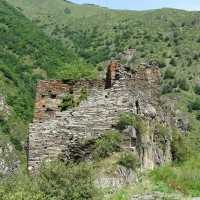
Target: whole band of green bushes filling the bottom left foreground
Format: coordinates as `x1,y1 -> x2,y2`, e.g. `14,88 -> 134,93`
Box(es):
0,163 -> 97,200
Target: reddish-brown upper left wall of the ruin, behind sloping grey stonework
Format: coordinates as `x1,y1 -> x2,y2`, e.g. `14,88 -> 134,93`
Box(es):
34,80 -> 105,122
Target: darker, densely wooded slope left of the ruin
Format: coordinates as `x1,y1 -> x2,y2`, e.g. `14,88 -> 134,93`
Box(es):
0,0 -> 97,169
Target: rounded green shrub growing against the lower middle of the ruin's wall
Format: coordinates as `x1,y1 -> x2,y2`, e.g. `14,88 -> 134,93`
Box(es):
93,131 -> 122,160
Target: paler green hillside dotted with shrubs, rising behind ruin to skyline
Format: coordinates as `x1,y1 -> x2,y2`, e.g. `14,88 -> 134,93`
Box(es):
7,0 -> 200,154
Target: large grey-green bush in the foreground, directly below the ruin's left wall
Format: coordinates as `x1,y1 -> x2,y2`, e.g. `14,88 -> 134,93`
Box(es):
38,163 -> 96,200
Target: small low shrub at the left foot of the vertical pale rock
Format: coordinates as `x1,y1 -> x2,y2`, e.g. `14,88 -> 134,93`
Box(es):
117,152 -> 139,170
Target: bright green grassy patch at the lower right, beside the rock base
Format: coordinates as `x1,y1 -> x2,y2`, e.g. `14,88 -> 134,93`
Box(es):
151,157 -> 200,197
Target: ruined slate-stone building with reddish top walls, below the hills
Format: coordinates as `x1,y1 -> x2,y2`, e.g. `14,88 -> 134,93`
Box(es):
28,54 -> 171,172
